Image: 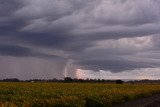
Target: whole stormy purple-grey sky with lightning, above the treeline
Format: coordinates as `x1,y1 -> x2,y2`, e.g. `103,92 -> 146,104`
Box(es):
0,0 -> 160,79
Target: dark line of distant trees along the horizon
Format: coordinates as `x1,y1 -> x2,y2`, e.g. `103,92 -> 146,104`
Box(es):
0,77 -> 160,84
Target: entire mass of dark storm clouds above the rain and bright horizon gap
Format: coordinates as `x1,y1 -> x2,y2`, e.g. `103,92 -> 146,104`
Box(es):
0,0 -> 160,78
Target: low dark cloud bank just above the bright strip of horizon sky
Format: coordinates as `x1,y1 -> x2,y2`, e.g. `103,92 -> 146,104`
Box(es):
77,60 -> 160,72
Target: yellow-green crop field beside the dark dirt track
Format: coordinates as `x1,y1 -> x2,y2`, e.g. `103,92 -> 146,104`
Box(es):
0,82 -> 160,107
